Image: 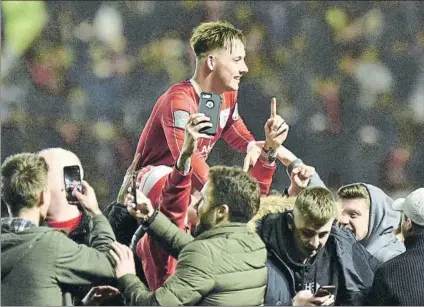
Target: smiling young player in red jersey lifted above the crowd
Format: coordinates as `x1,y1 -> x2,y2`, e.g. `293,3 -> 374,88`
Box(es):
132,21 -> 274,193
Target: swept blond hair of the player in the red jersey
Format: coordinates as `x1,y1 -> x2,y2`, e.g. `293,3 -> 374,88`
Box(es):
190,21 -> 246,57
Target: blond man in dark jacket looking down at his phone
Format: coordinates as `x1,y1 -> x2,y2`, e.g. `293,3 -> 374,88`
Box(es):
257,187 -> 375,306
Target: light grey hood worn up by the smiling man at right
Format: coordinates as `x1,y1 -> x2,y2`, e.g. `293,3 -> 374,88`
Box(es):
360,183 -> 404,258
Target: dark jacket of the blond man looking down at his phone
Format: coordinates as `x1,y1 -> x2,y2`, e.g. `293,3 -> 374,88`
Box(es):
257,212 -> 377,306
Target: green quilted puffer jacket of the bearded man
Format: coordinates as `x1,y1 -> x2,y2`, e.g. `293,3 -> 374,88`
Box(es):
118,213 -> 267,306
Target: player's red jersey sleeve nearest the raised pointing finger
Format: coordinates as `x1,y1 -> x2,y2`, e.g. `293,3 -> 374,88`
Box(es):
222,92 -> 255,152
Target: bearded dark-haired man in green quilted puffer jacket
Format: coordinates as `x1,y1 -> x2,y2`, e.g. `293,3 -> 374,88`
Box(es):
111,166 -> 267,306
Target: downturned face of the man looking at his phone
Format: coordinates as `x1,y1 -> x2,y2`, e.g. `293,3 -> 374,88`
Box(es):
293,210 -> 334,258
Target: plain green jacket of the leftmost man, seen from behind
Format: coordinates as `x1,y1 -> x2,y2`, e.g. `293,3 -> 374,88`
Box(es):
1,215 -> 115,306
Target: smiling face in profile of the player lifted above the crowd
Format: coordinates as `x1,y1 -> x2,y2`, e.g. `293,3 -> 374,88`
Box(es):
213,39 -> 249,91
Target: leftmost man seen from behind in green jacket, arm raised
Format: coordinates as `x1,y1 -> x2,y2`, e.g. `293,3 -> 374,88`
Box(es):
1,153 -> 115,306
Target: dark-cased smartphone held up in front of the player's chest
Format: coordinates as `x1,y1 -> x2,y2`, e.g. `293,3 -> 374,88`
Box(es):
197,92 -> 222,135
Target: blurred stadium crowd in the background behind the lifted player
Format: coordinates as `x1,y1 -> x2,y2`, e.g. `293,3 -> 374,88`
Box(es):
1,1 -> 424,212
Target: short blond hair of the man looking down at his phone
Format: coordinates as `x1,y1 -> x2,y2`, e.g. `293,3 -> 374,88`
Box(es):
293,187 -> 340,227
